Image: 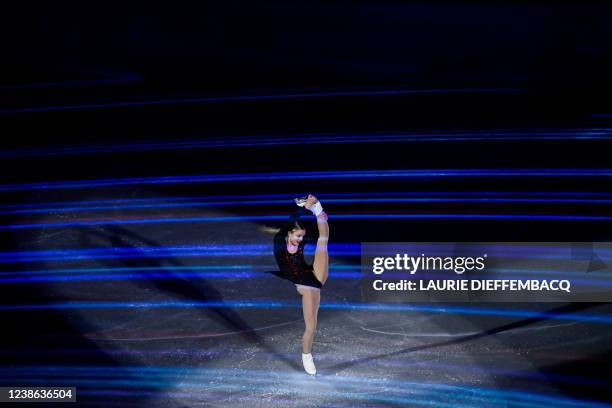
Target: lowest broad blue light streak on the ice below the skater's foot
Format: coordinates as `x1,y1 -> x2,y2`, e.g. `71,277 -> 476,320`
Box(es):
0,366 -> 606,408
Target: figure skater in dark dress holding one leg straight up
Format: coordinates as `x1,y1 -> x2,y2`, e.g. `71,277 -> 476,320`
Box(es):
274,194 -> 329,375
